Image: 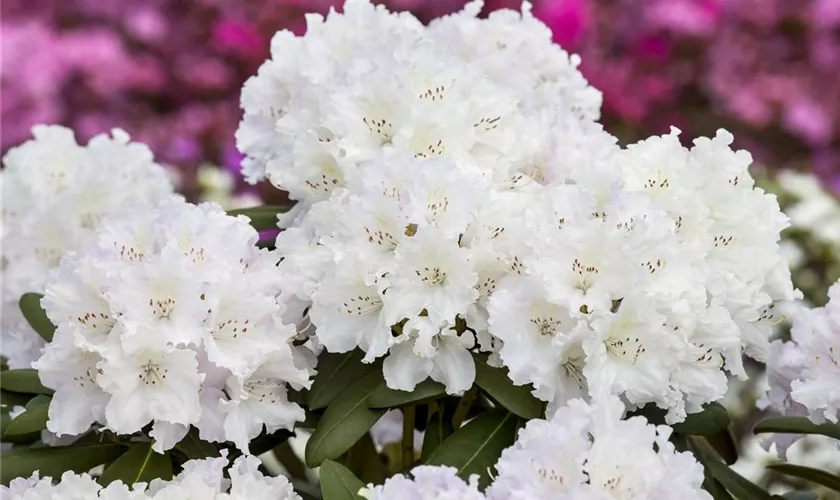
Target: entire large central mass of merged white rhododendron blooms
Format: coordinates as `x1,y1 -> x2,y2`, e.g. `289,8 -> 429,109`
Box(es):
237,0 -> 794,422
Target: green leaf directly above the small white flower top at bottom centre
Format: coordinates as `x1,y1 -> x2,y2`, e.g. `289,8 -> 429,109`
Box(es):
425,408 -> 519,488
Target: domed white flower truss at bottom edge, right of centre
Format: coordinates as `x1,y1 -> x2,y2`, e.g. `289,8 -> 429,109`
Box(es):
487,396 -> 712,500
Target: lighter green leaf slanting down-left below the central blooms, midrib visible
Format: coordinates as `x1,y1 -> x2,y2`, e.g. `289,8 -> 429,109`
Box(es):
305,370 -> 385,467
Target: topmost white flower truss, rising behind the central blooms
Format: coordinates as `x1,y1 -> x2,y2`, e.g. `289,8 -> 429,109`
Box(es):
236,0 -> 601,223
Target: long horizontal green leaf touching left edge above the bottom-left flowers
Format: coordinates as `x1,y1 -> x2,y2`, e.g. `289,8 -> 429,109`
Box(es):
0,443 -> 126,485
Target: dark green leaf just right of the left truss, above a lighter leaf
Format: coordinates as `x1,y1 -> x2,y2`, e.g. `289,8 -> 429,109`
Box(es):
307,349 -> 381,410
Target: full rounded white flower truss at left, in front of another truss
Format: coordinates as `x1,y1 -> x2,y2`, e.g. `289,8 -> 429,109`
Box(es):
34,197 -> 314,452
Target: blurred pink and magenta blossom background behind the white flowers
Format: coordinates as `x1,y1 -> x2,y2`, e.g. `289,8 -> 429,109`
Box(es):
0,0 -> 840,494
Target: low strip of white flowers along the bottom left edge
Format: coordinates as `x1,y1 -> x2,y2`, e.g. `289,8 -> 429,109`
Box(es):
0,451 -> 300,500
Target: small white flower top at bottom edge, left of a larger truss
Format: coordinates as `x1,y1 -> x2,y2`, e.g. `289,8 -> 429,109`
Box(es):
360,465 -> 484,500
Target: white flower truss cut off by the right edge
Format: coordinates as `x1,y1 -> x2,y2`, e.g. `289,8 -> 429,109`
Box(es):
768,282 -> 840,423
